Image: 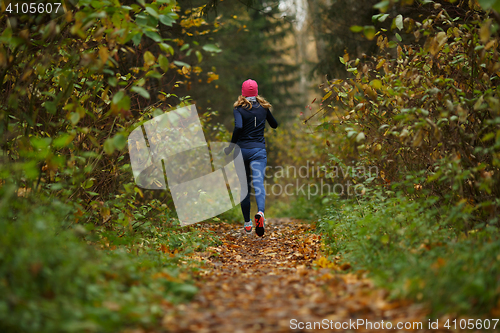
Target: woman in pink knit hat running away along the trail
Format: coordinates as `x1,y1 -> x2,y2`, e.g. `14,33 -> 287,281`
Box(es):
225,79 -> 278,237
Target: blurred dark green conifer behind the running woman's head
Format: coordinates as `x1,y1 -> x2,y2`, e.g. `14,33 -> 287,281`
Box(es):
182,0 -> 299,128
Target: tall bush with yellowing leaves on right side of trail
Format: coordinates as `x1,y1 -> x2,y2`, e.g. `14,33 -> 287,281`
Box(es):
323,1 -> 500,230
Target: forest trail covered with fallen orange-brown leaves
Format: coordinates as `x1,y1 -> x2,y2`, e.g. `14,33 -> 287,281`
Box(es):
162,219 -> 425,333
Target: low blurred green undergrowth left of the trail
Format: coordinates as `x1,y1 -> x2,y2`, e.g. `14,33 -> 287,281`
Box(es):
0,185 -> 217,332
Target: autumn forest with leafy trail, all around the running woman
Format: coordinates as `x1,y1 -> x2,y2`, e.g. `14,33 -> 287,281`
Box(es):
0,0 -> 500,332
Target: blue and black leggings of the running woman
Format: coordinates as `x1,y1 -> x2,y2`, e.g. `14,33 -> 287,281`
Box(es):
240,148 -> 267,222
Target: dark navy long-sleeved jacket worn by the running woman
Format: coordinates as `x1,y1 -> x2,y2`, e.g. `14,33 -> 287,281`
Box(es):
231,102 -> 278,148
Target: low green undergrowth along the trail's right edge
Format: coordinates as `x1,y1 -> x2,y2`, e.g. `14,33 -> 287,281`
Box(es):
318,185 -> 500,315
